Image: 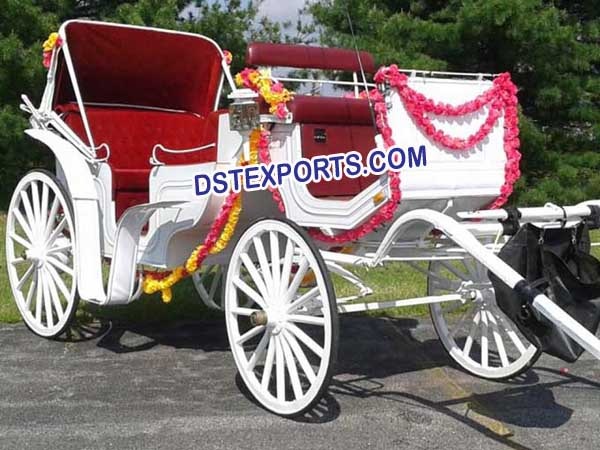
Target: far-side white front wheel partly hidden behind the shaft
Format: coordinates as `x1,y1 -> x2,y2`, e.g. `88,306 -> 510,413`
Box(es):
427,256 -> 541,380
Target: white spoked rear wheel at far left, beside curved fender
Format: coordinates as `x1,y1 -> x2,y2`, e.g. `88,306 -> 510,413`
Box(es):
6,170 -> 79,338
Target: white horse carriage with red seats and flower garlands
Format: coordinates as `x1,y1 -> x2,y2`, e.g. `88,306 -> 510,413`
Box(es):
6,20 -> 600,416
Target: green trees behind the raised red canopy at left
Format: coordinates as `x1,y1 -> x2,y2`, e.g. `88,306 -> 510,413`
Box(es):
0,0 -> 289,209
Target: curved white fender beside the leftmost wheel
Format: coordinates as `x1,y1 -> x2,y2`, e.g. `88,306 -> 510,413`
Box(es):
25,129 -> 106,303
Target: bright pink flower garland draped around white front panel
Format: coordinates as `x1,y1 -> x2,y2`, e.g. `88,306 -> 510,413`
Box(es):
251,65 -> 521,244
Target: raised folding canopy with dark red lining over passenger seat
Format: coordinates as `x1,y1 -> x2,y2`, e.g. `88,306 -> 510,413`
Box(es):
54,21 -> 223,117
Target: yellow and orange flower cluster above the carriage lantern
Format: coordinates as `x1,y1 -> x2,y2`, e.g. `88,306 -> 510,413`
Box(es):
235,68 -> 294,119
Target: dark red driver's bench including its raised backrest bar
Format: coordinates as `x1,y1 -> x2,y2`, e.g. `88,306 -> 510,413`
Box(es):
246,43 -> 377,197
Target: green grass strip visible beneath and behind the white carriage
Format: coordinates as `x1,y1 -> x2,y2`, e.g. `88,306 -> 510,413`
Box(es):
0,214 -> 427,323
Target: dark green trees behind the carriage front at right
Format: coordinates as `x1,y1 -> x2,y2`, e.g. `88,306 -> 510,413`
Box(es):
308,0 -> 600,204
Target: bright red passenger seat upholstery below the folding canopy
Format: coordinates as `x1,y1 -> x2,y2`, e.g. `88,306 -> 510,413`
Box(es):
57,104 -> 226,217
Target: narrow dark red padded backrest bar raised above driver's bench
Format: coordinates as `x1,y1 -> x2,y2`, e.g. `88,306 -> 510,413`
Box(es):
246,42 -> 377,73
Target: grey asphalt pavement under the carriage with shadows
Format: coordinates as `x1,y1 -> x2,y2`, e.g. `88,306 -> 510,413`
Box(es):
0,317 -> 600,450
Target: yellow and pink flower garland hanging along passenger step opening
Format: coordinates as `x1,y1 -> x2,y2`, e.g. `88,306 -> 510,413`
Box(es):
142,128 -> 268,303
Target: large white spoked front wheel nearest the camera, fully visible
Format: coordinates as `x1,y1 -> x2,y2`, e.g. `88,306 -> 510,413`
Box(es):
225,219 -> 338,417
